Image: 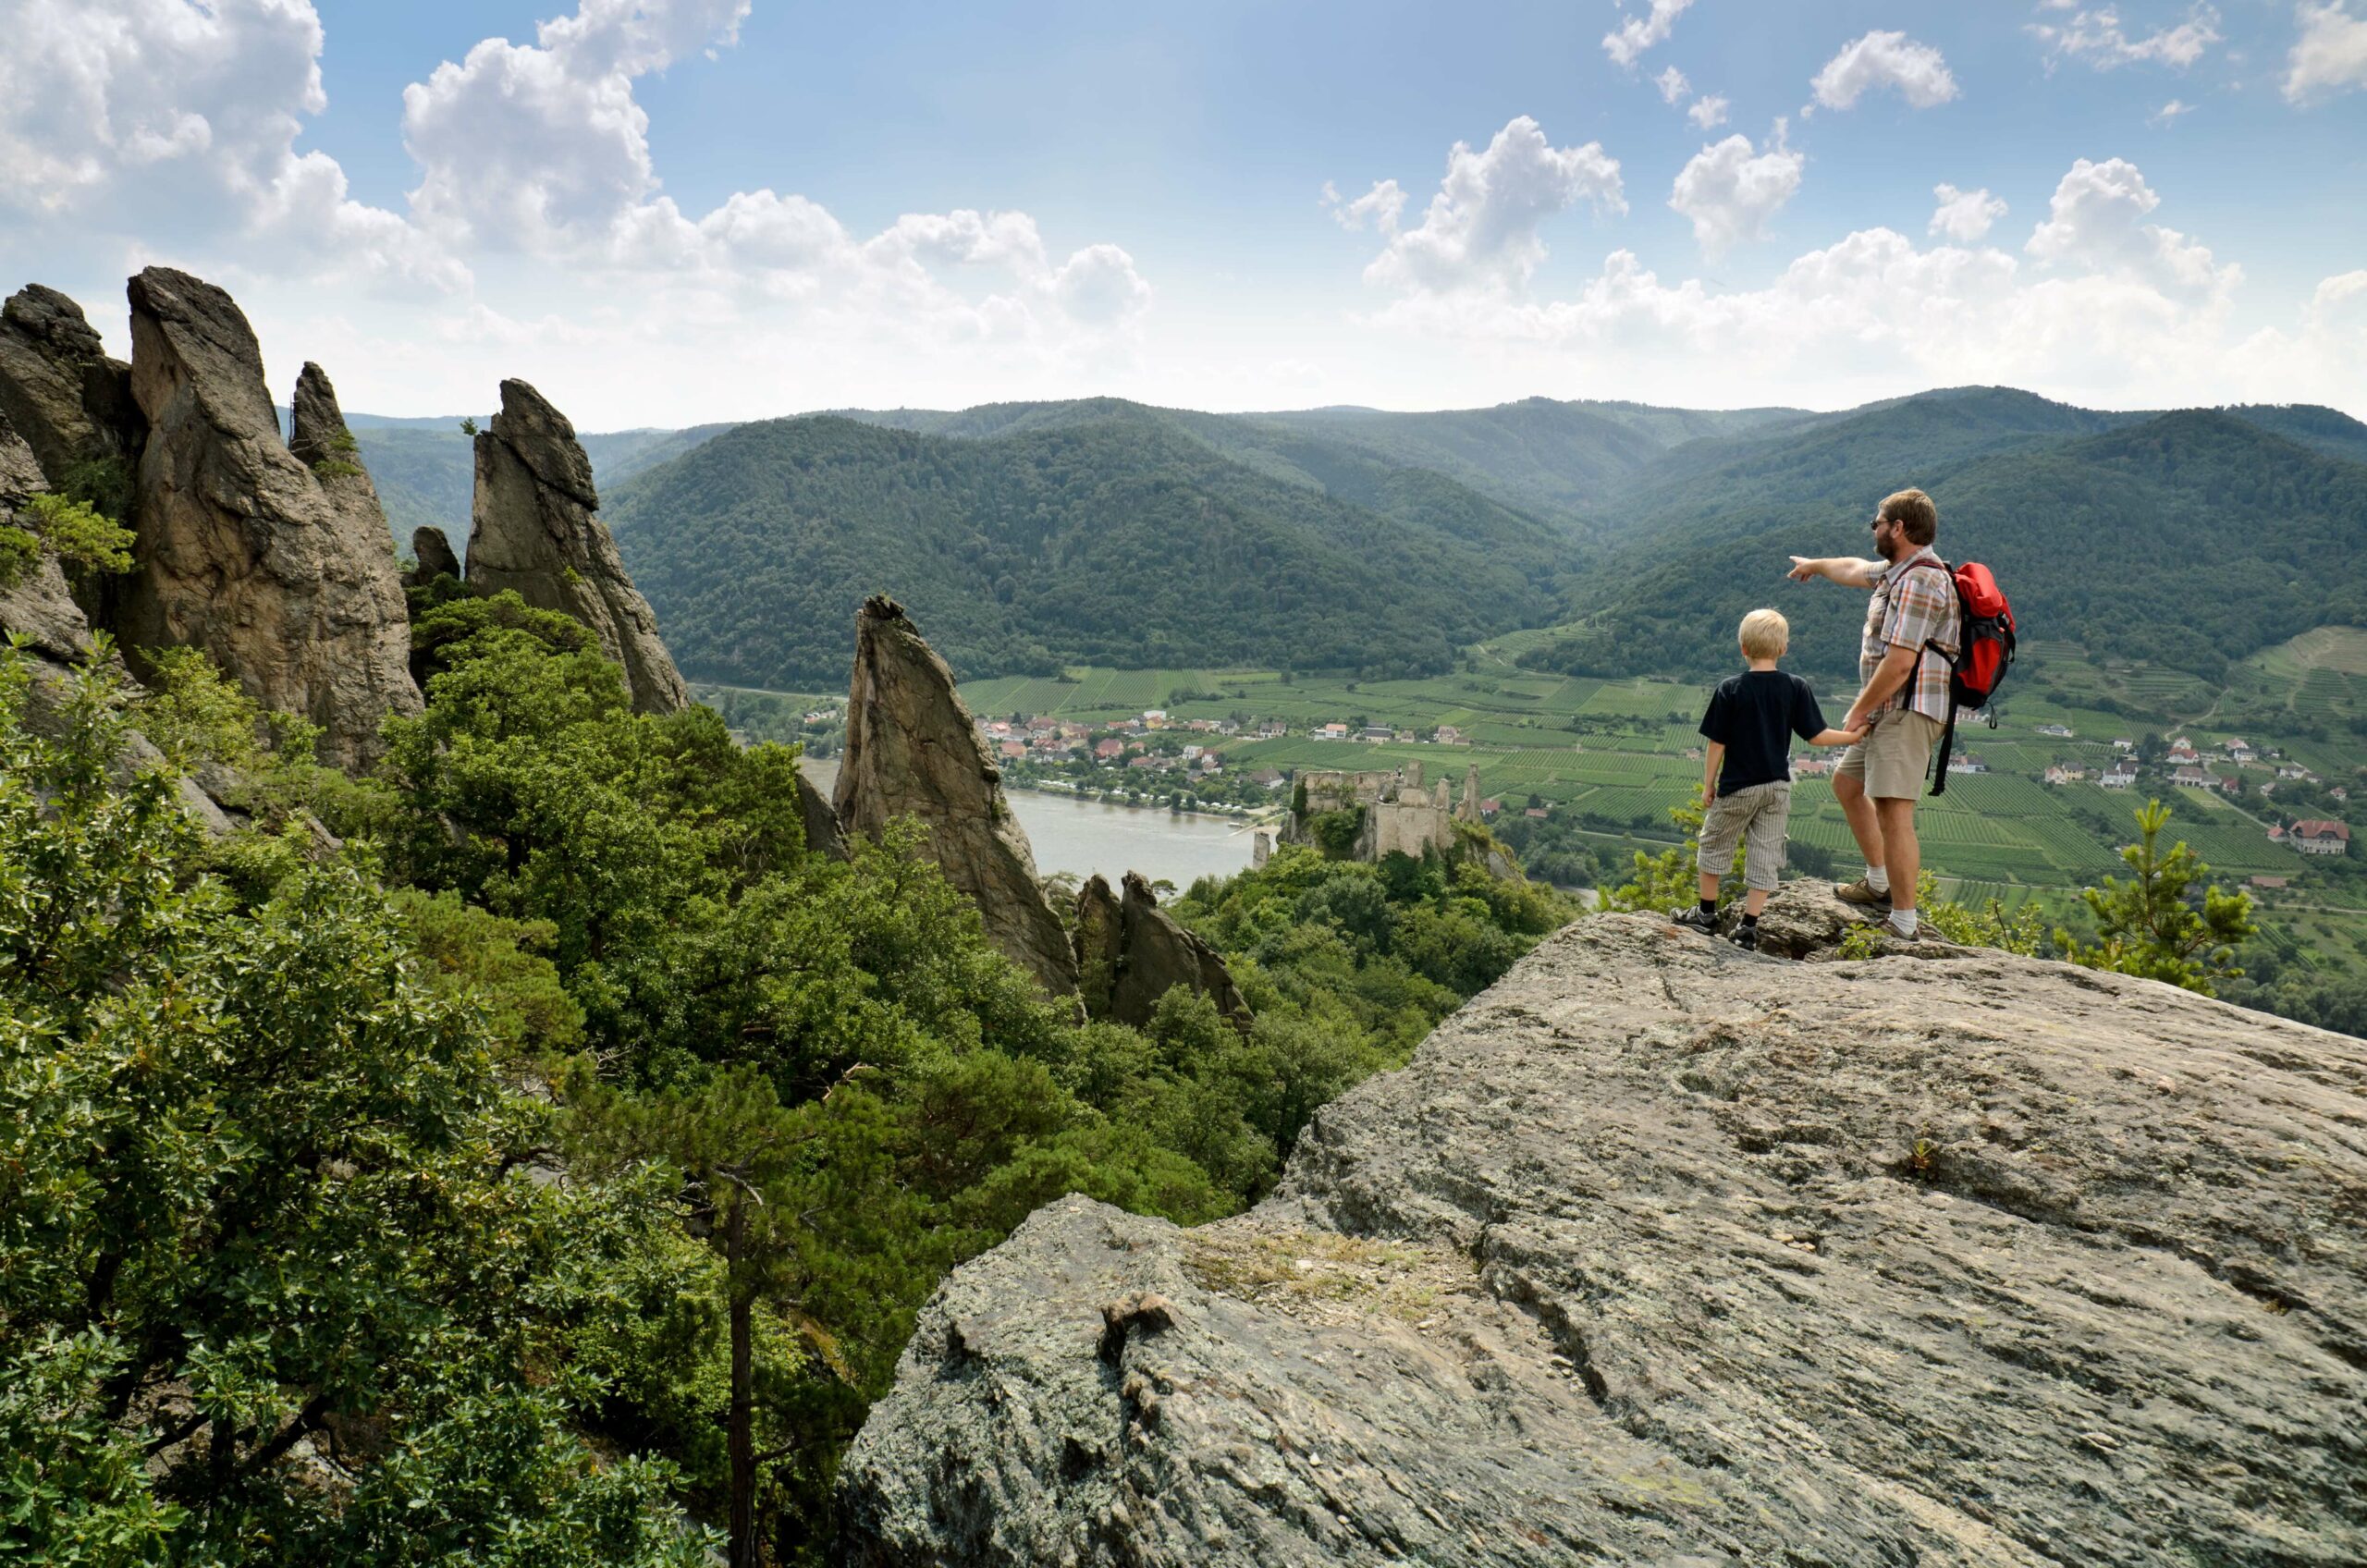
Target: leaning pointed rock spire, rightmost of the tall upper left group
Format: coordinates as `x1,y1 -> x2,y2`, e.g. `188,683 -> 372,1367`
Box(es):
469,381 -> 692,713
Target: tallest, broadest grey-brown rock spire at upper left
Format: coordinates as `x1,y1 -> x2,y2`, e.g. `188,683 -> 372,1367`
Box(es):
118,267 -> 419,767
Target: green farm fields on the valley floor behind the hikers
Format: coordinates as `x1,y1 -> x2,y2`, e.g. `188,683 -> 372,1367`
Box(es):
701,628 -> 2367,964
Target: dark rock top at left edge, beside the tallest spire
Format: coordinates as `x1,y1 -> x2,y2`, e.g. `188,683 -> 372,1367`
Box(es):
0,284 -> 147,490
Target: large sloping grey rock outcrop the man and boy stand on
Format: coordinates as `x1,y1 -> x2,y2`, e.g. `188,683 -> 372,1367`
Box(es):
840,914 -> 2367,1568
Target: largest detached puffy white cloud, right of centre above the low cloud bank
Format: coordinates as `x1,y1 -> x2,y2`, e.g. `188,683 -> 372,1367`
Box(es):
1366,114 -> 1626,294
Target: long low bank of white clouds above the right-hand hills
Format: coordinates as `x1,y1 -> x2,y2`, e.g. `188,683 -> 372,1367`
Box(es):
1361,151 -> 2367,408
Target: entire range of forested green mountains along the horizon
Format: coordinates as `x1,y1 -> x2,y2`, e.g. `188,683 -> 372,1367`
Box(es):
319,386 -> 2367,687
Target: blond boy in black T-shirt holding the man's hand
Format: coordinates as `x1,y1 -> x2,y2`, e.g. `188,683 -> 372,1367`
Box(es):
1675,608 -> 1863,948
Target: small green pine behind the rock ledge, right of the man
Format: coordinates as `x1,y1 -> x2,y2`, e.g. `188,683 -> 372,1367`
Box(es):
2054,801 -> 2256,998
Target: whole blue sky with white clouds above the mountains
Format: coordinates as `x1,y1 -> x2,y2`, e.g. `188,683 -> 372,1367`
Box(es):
0,0 -> 2367,429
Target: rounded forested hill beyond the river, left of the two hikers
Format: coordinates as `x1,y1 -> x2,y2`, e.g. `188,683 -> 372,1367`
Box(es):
606,417 -> 1572,684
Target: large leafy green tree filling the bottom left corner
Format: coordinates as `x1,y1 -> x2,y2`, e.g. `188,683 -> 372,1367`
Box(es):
0,661 -> 703,1563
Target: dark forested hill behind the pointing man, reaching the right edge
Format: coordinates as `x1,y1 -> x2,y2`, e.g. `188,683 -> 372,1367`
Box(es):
1525,393 -> 2367,680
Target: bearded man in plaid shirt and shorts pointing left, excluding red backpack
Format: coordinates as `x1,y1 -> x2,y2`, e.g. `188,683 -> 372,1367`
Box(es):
1789,490 -> 1962,938
